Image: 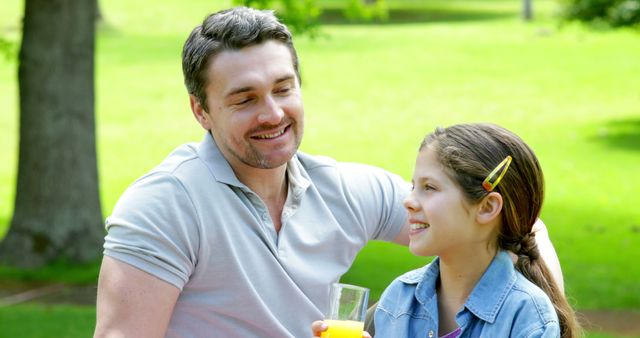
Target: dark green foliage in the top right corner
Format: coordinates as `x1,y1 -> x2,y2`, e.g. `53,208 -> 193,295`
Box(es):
564,0 -> 640,28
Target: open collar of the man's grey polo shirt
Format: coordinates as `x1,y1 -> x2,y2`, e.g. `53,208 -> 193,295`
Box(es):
198,133 -> 311,197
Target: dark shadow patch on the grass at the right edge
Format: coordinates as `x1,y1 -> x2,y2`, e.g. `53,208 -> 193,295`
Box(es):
590,114 -> 640,151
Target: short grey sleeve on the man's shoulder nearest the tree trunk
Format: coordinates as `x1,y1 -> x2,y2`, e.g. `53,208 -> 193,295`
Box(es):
104,173 -> 199,290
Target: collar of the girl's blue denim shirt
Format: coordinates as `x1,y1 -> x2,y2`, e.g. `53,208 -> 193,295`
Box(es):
399,251 -> 516,323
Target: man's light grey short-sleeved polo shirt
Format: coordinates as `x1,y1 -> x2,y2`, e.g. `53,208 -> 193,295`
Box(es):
104,134 -> 408,337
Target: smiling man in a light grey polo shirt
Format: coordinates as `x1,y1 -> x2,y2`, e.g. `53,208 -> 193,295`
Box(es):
95,8 -> 555,337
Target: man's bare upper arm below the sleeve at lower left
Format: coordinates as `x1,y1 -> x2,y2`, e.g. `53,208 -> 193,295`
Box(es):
94,256 -> 180,338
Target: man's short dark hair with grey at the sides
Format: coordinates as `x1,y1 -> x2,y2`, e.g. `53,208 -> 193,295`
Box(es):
182,7 -> 300,111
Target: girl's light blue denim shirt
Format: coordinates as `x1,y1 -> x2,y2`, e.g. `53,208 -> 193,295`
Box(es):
374,251 -> 560,338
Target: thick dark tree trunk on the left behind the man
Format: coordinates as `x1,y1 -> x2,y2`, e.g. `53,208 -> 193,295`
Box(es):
0,0 -> 104,267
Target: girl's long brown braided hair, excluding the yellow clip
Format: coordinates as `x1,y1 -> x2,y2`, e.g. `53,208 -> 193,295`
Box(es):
420,123 -> 581,337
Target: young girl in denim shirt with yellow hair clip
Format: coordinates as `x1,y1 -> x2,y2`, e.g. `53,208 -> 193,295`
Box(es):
374,124 -> 581,338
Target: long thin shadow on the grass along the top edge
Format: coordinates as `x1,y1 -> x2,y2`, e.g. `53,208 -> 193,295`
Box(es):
319,8 -> 517,25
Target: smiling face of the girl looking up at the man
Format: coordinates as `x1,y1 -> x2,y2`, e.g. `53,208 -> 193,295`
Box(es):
404,146 -> 487,257
